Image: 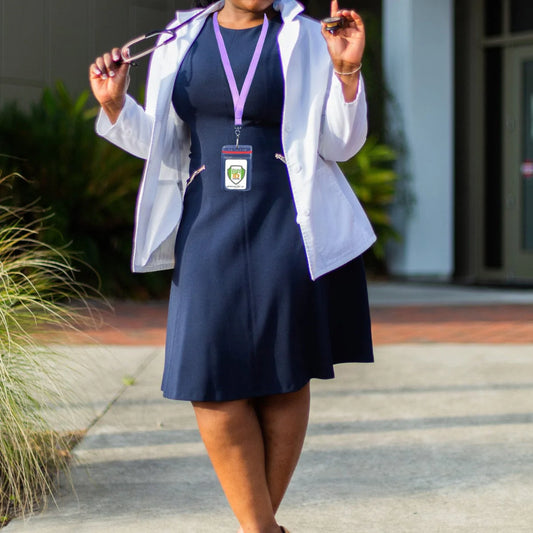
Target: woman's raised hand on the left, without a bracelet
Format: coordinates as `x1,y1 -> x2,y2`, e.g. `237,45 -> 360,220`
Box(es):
89,48 -> 130,124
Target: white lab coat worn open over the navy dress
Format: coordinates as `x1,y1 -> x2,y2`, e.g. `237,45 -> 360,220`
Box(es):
96,0 -> 375,279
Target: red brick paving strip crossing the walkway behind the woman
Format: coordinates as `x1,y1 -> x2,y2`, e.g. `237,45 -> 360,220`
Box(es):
55,302 -> 533,346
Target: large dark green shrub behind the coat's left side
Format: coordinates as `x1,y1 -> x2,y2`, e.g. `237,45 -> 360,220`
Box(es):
0,83 -> 168,297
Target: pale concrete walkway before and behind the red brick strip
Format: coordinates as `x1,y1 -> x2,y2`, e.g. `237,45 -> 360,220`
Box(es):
5,285 -> 533,533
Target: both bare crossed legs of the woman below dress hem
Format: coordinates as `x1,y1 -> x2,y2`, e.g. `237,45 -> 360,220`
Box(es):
193,385 -> 309,533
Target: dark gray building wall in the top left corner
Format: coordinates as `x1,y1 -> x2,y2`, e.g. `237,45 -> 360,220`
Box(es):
0,0 -> 190,106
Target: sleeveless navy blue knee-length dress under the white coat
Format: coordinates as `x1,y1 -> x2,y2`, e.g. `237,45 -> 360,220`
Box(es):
162,14 -> 373,401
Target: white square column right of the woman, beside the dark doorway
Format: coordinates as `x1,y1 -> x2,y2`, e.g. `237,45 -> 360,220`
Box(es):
383,0 -> 454,279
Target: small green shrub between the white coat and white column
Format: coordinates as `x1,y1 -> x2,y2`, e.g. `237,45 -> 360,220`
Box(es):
340,137 -> 399,264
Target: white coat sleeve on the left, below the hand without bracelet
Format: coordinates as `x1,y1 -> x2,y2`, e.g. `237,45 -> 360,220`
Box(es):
96,95 -> 154,159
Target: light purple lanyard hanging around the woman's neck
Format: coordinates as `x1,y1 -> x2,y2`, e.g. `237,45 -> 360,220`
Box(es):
213,13 -> 268,140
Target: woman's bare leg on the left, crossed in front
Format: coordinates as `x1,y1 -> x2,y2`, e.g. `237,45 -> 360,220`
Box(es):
193,400 -> 280,533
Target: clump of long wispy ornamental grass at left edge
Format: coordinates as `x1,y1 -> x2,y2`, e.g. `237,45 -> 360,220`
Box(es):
0,174 -> 95,526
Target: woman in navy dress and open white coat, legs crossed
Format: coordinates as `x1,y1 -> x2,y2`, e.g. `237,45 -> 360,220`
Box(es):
90,0 -> 375,533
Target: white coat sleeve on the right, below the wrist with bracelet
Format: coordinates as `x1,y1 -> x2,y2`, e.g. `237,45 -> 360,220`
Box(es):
318,75 -> 368,161
